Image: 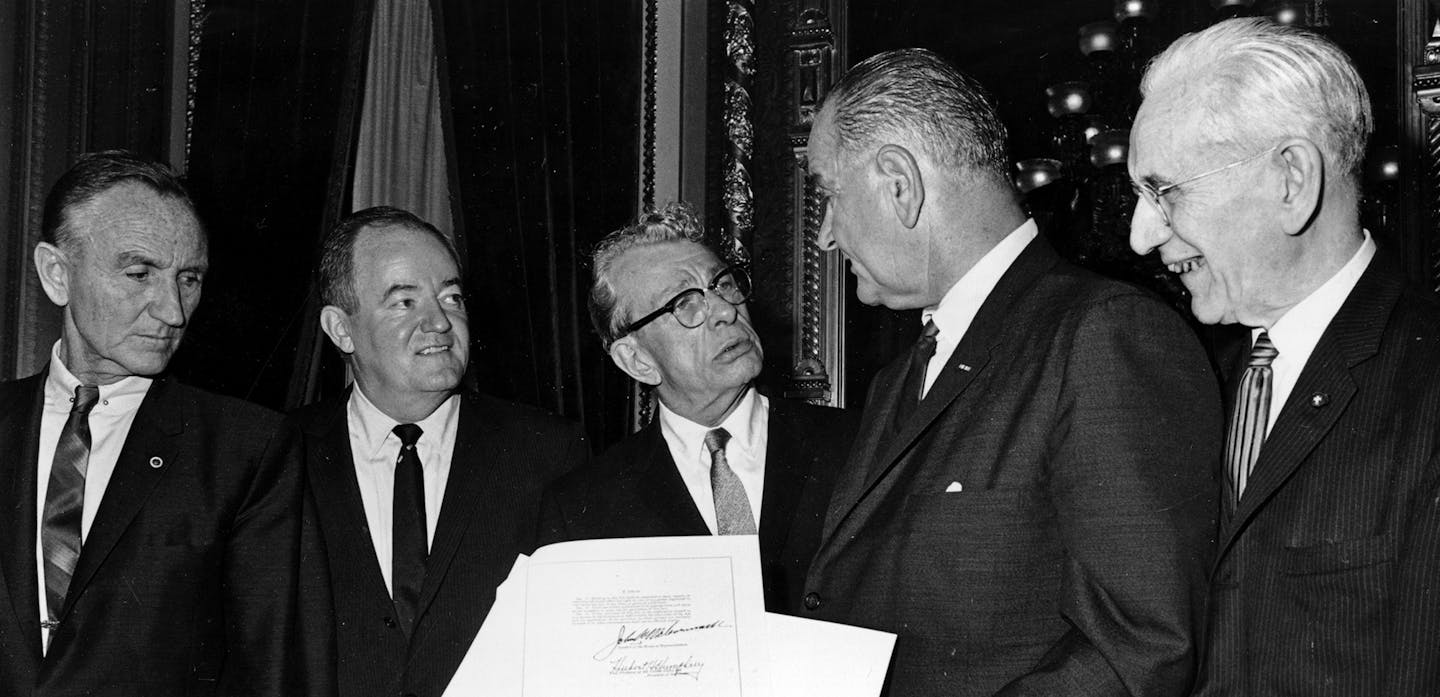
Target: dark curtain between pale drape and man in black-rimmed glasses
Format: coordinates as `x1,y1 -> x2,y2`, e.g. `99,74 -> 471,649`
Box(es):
433,0 -> 641,446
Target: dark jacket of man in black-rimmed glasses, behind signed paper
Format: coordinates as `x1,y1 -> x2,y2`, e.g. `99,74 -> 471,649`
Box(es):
540,399 -> 855,615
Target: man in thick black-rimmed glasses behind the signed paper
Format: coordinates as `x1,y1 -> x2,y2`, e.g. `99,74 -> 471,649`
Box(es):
541,204 -> 854,613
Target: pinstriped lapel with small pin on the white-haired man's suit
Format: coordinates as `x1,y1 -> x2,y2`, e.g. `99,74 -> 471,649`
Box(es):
1215,256 -> 1403,566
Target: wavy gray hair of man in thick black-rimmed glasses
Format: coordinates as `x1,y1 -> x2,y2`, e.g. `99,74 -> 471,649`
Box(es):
590,202 -> 708,351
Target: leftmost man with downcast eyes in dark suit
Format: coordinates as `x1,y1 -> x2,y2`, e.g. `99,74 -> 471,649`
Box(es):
0,151 -> 301,697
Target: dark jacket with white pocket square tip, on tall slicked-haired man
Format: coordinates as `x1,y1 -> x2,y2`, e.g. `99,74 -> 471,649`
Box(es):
805,239 -> 1221,697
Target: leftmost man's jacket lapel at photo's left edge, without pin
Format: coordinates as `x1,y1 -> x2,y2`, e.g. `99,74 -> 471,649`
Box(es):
0,373 -> 46,661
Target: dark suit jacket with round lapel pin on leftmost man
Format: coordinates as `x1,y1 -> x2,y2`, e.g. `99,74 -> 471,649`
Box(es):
0,374 -> 301,697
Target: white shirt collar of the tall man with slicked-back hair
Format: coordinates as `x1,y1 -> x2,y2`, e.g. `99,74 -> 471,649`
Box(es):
920,219 -> 1040,399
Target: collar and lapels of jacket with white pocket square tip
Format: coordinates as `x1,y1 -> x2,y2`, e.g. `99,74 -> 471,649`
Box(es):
821,238 -> 1060,549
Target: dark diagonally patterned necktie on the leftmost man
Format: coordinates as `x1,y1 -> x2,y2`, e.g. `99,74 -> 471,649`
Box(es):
40,385 -> 99,629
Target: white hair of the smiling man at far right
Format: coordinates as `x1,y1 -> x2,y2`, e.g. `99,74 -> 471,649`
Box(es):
1140,17 -> 1375,181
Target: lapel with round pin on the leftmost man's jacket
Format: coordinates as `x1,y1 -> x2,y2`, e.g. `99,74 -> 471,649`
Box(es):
60,377 -> 180,619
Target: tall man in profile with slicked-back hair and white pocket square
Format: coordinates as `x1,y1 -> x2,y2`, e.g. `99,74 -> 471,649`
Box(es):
804,49 -> 1220,696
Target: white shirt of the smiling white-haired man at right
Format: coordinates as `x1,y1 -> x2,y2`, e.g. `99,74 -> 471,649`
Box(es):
1250,230 -> 1375,433
